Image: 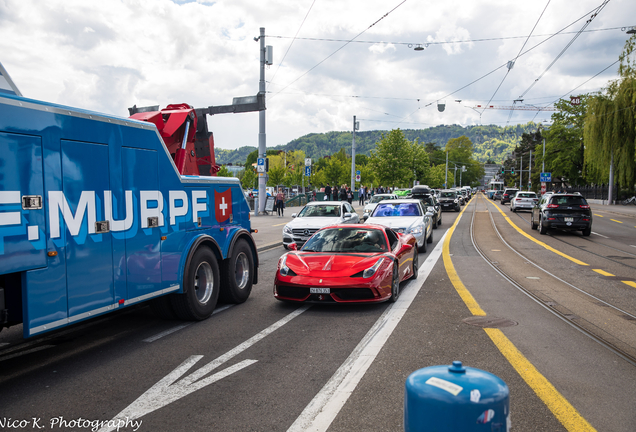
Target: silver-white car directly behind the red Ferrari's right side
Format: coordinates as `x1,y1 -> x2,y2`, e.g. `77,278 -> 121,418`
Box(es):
365,199 -> 433,252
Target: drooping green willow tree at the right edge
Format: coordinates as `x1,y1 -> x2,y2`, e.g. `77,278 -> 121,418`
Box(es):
583,35 -> 636,189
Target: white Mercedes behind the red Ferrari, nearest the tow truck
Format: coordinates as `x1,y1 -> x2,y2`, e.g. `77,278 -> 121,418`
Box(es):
283,201 -> 360,249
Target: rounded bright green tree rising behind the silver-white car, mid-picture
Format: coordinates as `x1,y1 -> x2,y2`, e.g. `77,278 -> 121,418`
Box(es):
369,129 -> 413,186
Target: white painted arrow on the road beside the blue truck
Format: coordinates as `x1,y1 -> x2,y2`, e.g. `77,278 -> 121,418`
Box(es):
99,306 -> 310,432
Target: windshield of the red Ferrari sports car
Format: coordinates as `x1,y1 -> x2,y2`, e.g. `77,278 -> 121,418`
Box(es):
301,228 -> 389,253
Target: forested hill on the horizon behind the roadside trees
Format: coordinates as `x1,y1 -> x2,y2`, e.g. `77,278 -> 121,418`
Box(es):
215,122 -> 538,165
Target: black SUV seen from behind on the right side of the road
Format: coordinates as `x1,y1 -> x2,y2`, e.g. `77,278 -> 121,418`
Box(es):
530,193 -> 592,236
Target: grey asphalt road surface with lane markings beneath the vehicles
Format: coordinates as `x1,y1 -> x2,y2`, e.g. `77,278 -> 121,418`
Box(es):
0,198 -> 636,431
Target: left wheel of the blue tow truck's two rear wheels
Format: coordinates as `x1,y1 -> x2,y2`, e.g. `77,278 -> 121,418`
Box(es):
172,247 -> 221,321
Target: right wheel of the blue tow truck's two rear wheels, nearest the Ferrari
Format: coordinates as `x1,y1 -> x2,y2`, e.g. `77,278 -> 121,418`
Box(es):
220,239 -> 254,303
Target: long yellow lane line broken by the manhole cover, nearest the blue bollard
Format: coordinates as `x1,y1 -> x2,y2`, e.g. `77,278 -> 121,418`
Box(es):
442,202 -> 596,432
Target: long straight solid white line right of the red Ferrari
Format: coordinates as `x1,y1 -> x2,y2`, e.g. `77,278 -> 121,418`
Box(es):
287,236 -> 448,432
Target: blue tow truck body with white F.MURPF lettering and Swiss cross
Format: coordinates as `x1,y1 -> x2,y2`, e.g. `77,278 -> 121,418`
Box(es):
0,64 -> 258,338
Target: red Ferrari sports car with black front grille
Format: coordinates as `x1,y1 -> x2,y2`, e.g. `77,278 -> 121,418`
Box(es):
274,224 -> 418,303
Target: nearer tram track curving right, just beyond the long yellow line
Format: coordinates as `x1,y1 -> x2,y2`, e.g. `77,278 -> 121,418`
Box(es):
470,197 -> 636,366
